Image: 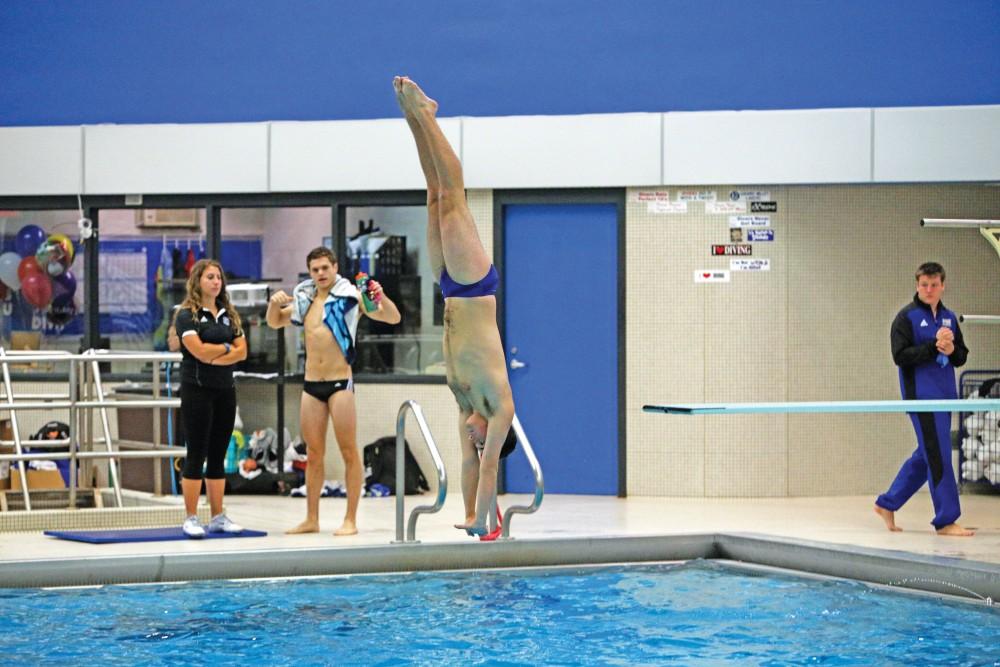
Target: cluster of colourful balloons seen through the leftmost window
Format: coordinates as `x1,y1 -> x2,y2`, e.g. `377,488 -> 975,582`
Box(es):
0,225 -> 76,325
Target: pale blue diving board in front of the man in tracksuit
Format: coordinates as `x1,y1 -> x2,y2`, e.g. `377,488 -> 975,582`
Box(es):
642,398 -> 1000,415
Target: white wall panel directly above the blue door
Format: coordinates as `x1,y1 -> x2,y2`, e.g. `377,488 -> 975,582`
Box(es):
462,114 -> 660,188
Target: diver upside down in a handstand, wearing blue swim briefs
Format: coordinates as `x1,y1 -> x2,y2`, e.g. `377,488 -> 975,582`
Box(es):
392,76 -> 514,535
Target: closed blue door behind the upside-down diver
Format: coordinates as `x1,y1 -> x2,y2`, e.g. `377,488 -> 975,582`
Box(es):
503,204 -> 619,495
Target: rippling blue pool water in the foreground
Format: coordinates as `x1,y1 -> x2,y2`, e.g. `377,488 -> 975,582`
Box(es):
0,561 -> 1000,667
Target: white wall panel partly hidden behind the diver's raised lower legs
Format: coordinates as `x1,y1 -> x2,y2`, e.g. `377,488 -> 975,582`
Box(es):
271,118 -> 462,192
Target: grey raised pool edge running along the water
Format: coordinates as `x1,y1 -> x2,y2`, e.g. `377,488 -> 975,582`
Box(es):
0,533 -> 1000,600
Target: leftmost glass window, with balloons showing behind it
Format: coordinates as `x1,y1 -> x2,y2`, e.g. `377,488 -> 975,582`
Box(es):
0,211 -> 85,373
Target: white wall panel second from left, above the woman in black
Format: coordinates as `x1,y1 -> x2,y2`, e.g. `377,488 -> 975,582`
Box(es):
84,123 -> 267,194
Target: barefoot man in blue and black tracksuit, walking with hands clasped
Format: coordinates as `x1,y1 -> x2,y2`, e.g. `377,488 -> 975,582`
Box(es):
875,262 -> 973,536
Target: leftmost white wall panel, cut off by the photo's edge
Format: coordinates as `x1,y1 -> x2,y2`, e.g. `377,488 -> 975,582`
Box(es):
0,127 -> 83,195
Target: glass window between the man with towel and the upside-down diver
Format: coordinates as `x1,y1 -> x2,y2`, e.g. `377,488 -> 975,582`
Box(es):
340,206 -> 445,375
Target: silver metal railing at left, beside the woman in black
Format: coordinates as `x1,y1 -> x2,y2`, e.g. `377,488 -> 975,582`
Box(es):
0,347 -> 187,512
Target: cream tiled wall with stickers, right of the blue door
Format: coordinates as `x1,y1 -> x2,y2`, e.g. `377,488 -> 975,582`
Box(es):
626,185 -> 1000,497
